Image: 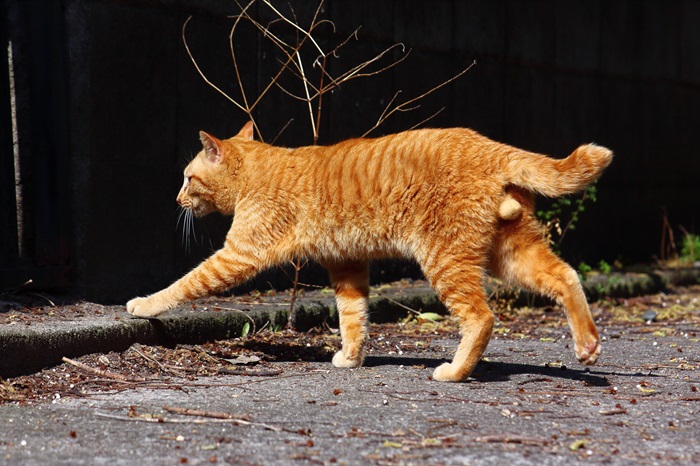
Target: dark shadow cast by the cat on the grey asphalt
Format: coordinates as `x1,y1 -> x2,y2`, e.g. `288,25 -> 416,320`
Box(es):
364,356 -> 620,387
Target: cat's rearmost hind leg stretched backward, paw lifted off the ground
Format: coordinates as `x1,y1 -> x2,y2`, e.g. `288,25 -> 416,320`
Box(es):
490,214 -> 601,365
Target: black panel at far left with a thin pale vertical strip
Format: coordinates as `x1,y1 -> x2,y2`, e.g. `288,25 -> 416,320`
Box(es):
0,1 -> 72,289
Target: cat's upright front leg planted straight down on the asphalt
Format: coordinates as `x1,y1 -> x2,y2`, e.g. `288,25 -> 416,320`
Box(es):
325,261 -> 369,367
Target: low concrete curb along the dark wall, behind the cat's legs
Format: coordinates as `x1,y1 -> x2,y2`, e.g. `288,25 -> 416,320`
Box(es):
0,267 -> 700,377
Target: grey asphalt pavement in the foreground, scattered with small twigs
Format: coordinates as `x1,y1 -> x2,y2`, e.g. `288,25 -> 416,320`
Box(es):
0,332 -> 700,465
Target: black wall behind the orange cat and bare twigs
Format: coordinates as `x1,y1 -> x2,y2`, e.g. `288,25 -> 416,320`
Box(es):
0,0 -> 700,301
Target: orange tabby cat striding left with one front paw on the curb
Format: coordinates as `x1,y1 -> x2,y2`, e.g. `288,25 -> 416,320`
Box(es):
127,123 -> 612,381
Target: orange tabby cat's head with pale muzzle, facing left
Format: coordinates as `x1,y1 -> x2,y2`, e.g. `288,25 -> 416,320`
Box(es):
177,122 -> 253,217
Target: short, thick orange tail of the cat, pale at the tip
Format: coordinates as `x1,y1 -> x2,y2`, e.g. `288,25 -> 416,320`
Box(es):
506,144 -> 613,197
